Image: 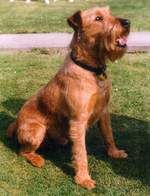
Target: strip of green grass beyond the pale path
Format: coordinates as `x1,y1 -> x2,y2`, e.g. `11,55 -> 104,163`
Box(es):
0,0 -> 150,33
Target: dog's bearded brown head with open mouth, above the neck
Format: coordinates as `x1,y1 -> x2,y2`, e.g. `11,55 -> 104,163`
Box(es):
68,7 -> 130,61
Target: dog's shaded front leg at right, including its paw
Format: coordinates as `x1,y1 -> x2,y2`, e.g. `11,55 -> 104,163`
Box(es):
98,108 -> 128,158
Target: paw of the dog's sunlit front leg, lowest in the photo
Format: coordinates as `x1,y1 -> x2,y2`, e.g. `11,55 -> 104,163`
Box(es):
75,176 -> 96,190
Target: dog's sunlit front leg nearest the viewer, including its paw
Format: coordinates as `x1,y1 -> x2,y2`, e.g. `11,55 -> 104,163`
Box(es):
69,120 -> 95,189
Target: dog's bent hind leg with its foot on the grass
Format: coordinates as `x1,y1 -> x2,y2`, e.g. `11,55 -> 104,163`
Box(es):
18,122 -> 46,167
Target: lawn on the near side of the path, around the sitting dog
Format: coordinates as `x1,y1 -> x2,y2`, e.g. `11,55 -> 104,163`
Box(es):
0,49 -> 150,196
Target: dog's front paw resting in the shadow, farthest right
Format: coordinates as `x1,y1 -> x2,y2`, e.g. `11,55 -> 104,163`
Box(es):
108,148 -> 128,159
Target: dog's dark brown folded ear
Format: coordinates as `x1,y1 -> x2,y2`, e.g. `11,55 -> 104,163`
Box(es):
67,10 -> 82,31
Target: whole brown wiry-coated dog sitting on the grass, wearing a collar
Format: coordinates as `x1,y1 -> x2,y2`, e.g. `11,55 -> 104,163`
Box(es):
8,8 -> 130,189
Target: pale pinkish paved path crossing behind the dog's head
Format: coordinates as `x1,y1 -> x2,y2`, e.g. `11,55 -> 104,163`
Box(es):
0,32 -> 150,51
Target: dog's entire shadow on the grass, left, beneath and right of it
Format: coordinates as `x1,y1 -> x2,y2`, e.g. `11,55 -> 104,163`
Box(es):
0,99 -> 150,185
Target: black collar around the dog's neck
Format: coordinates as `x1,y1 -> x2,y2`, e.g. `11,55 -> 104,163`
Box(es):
70,52 -> 107,75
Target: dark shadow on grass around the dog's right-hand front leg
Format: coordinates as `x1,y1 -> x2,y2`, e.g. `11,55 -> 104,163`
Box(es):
87,114 -> 150,185
